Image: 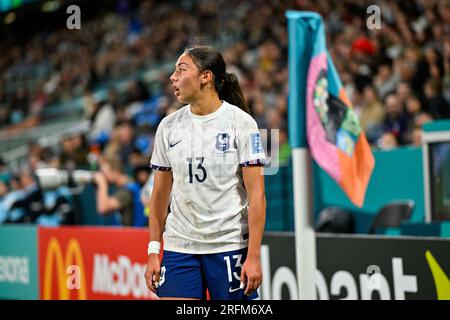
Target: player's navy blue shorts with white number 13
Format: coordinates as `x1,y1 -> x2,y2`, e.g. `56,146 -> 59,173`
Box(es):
156,248 -> 258,300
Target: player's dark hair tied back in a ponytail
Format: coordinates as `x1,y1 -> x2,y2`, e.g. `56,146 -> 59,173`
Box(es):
184,46 -> 249,113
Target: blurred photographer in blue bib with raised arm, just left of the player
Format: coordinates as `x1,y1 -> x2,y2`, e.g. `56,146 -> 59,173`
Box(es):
94,158 -> 144,226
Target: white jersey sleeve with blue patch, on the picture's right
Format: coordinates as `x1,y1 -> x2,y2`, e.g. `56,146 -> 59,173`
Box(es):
237,116 -> 266,167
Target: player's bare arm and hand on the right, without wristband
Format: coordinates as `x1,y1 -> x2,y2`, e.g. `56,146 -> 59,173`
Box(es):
241,166 -> 266,295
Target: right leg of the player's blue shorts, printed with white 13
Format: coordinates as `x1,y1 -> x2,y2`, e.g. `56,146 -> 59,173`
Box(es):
202,248 -> 258,300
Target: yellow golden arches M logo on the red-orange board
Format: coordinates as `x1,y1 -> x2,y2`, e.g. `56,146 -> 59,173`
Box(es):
43,237 -> 87,300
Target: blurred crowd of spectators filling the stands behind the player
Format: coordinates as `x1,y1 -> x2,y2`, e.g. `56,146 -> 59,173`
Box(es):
0,0 -> 450,226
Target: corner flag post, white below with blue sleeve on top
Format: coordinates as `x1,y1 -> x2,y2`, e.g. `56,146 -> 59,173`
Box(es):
286,11 -> 318,300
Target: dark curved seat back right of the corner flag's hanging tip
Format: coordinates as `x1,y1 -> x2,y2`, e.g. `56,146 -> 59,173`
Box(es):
369,200 -> 415,234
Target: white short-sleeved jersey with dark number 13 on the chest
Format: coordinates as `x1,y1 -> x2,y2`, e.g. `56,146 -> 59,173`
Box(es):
151,101 -> 265,254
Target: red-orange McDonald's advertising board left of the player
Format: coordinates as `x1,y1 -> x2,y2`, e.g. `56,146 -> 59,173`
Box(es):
39,227 -> 155,300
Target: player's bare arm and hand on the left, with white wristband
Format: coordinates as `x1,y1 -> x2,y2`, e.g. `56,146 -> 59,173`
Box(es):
145,171 -> 173,292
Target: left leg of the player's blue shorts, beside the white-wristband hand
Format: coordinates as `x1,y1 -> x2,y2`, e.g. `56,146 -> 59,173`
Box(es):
156,251 -> 206,299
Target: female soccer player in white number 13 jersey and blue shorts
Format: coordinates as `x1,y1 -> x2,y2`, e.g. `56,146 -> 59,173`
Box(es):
145,46 -> 266,300
